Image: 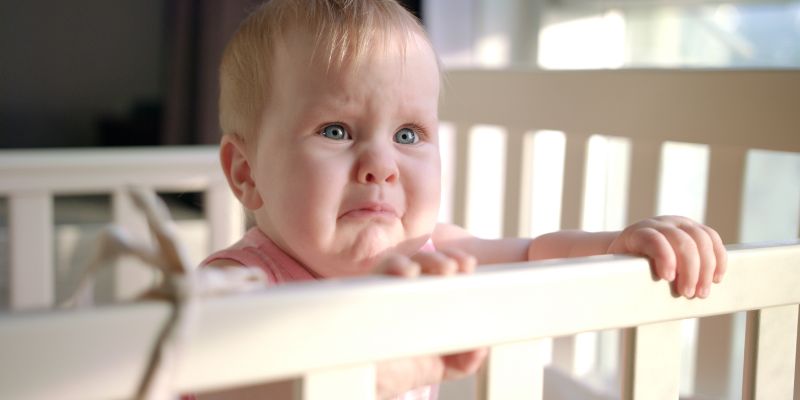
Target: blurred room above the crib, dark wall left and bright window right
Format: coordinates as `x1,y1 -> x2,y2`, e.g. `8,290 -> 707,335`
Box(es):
0,0 -> 800,148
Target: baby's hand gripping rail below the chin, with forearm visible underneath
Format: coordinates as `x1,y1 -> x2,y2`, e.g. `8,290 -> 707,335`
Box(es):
375,249 -> 488,398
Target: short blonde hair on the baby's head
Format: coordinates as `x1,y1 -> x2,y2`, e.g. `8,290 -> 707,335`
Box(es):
219,0 -> 427,141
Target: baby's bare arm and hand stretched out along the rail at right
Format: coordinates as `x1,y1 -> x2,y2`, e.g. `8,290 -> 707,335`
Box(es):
433,216 -> 727,298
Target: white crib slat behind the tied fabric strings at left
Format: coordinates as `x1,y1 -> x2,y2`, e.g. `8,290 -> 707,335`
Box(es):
111,189 -> 155,300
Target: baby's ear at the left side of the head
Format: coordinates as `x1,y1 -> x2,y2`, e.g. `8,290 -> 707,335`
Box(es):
219,134 -> 264,210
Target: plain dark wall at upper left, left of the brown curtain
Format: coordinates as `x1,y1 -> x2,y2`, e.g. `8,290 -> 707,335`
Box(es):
0,0 -> 165,148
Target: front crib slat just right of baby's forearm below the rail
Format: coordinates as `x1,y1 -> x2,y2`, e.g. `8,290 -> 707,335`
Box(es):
478,340 -> 545,400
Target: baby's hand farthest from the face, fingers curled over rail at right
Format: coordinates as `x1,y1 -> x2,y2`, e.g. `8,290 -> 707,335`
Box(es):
608,216 -> 727,298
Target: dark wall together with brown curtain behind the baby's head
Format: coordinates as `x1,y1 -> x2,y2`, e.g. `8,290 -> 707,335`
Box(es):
0,0 -> 423,148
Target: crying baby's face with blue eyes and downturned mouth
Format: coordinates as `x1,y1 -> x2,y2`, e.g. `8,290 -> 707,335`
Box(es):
250,30 -> 440,277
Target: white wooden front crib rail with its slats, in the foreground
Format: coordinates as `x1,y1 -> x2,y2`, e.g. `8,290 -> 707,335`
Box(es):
0,242 -> 800,400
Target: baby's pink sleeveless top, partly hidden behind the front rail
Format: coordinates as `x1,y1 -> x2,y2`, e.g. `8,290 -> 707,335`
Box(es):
201,228 -> 439,400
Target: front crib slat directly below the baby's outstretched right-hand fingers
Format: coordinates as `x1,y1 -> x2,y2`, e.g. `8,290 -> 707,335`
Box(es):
622,320 -> 681,400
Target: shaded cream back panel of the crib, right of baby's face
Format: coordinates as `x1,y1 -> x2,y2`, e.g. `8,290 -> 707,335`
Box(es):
441,70 -> 800,397
